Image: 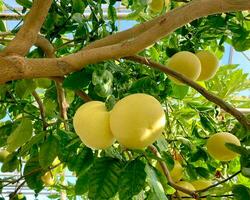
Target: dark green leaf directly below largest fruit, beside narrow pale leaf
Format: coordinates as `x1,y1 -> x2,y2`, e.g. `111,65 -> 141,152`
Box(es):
119,159 -> 147,200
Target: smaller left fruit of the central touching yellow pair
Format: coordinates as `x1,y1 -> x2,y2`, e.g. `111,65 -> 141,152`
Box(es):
73,101 -> 114,149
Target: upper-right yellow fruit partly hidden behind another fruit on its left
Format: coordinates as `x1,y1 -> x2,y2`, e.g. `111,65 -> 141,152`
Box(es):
196,51 -> 219,81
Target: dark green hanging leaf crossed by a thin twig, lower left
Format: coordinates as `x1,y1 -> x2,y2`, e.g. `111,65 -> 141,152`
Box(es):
24,157 -> 43,193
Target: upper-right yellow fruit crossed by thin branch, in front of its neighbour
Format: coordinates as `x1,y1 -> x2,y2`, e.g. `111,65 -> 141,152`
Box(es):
167,51 -> 201,84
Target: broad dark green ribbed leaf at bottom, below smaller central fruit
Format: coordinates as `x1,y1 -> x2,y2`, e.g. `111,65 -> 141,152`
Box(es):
88,157 -> 121,200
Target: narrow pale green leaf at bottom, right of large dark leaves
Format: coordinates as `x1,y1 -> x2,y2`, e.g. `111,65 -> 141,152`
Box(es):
145,164 -> 167,200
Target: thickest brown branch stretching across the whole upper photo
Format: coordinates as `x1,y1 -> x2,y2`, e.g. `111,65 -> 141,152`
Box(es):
0,0 -> 250,83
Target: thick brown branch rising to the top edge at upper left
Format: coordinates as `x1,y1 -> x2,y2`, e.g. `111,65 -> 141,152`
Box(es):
2,0 -> 52,56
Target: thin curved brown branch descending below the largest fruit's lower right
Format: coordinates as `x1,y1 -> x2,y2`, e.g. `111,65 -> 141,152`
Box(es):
148,145 -> 199,199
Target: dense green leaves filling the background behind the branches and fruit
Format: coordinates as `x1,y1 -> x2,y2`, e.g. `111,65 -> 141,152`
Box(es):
0,0 -> 250,200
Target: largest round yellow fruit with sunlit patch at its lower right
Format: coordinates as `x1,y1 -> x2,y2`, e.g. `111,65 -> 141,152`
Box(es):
110,93 -> 166,149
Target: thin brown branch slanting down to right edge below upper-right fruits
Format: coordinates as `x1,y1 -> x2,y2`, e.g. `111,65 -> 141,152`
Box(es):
126,56 -> 250,129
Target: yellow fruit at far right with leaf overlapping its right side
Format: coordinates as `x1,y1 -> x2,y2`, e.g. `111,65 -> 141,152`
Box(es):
207,132 -> 240,161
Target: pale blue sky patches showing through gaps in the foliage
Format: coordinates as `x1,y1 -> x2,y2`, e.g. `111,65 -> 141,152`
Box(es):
0,0 -> 250,199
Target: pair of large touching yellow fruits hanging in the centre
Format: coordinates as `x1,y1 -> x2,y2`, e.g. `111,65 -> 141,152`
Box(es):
73,93 -> 166,149
